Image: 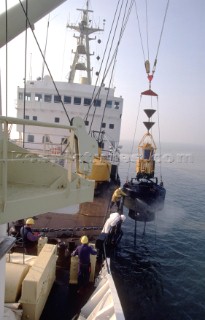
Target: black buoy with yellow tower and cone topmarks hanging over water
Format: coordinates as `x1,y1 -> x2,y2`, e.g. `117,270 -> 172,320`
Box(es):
123,87 -> 166,222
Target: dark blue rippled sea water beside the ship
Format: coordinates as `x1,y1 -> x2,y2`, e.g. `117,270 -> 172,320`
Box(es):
111,145 -> 205,320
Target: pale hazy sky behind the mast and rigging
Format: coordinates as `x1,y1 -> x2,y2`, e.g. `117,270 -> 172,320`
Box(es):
0,0 -> 205,145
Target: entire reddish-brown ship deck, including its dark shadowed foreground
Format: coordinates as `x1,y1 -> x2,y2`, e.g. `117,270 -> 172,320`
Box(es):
10,184 -> 118,320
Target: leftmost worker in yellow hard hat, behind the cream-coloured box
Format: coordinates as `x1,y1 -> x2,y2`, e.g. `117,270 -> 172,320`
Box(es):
20,218 -> 41,255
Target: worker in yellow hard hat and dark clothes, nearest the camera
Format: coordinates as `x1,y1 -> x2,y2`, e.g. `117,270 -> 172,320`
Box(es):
72,235 -> 97,289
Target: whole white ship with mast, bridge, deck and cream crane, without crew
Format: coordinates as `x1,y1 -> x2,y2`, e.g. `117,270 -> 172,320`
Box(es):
0,0 -> 124,320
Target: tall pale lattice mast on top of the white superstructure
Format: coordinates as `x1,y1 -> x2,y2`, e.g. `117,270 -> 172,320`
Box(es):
67,0 -> 104,85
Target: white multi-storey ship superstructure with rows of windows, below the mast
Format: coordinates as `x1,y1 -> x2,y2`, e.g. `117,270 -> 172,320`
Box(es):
17,76 -> 123,150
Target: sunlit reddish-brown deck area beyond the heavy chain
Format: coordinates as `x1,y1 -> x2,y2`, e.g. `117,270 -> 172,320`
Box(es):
35,184 -> 114,239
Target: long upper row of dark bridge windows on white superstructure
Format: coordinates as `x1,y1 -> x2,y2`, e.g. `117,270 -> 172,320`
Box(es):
18,92 -> 120,109
